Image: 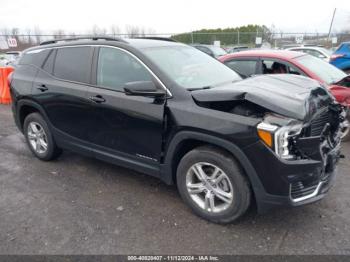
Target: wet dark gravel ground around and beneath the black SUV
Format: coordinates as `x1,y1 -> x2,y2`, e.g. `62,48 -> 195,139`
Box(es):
0,105 -> 350,255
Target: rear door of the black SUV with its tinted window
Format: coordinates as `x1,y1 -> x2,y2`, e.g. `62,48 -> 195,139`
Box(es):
33,46 -> 93,144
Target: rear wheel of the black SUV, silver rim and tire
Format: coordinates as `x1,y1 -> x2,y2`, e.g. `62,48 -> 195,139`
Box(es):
23,113 -> 62,161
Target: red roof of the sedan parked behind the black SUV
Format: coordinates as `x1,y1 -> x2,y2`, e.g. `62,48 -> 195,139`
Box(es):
220,49 -> 305,61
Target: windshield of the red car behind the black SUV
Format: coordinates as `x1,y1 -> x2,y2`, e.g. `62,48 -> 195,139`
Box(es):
296,55 -> 346,84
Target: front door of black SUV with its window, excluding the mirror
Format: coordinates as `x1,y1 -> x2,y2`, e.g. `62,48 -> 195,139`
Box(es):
89,47 -> 166,164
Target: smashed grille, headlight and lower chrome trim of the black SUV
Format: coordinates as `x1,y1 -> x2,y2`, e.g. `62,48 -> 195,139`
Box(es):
257,103 -> 345,203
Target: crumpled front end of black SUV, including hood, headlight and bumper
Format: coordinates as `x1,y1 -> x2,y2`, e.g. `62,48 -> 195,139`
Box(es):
193,76 -> 346,208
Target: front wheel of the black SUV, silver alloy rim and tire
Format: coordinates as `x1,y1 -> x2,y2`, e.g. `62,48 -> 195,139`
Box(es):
176,146 -> 252,224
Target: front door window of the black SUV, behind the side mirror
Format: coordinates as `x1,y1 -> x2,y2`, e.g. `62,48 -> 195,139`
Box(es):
97,47 -> 152,91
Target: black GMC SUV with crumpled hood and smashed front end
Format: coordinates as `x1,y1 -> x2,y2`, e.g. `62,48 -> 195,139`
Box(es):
10,38 -> 344,223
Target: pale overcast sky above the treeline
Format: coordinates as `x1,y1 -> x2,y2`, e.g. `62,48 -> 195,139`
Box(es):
0,0 -> 350,33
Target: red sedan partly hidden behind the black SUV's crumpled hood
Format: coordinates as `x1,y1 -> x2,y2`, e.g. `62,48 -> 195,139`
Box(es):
219,50 -> 350,140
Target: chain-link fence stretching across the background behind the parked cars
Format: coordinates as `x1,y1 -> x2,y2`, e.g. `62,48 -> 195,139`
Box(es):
0,31 -> 350,52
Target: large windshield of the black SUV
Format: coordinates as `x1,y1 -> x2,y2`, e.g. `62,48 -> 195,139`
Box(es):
143,45 -> 241,89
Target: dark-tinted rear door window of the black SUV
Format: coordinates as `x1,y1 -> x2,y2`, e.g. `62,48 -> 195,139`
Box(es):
54,47 -> 92,83
